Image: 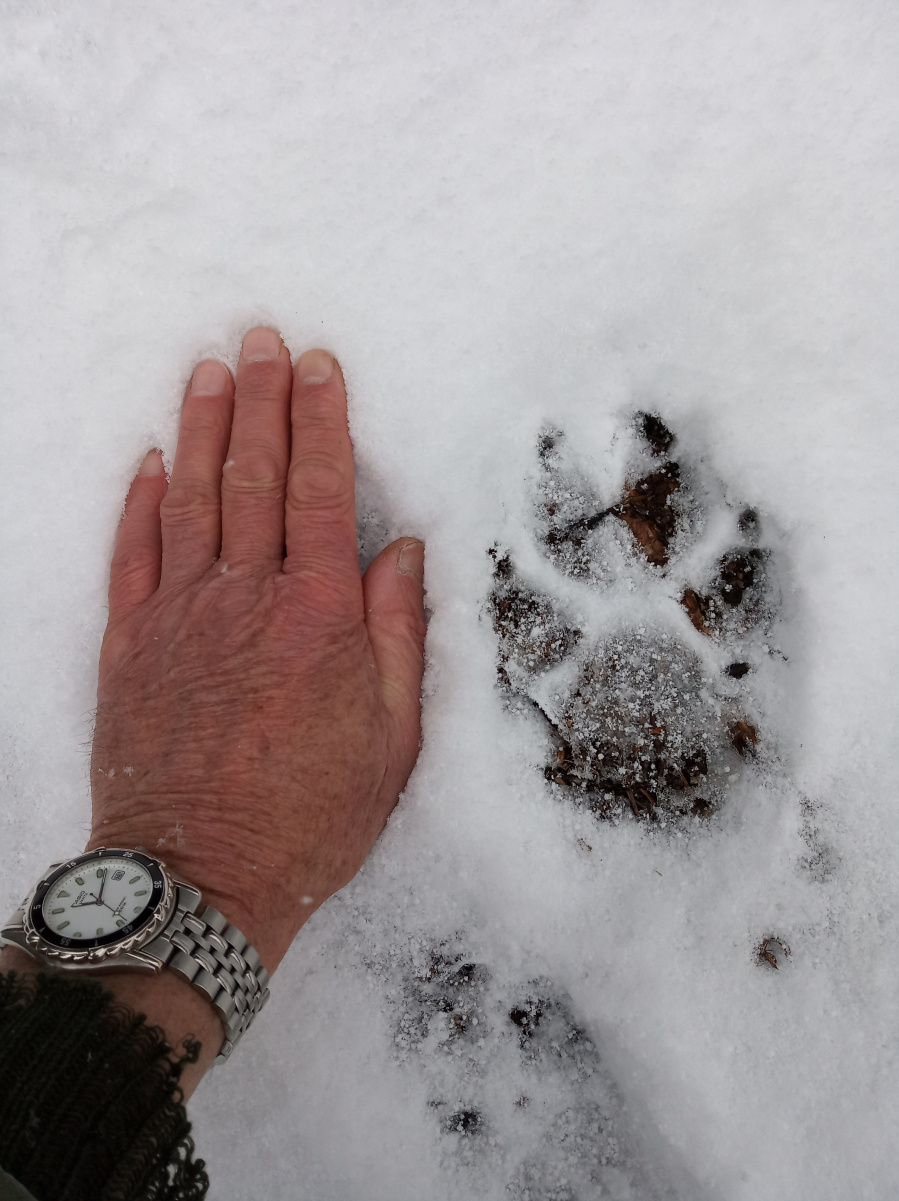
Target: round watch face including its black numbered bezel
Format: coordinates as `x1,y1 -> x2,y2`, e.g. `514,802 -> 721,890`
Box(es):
30,850 -> 166,951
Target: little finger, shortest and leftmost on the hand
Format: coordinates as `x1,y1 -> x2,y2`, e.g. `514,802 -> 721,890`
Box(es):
109,450 -> 166,621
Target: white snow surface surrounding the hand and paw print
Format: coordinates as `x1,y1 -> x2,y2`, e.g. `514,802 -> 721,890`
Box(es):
0,0 -> 899,1201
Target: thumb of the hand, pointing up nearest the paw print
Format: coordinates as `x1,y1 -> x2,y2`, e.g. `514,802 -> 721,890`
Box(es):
362,538 -> 426,793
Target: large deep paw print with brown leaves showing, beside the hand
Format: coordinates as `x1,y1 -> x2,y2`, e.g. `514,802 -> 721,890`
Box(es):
487,413 -> 783,824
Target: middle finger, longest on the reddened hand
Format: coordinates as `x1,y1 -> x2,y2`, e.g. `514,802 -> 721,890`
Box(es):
222,325 -> 290,569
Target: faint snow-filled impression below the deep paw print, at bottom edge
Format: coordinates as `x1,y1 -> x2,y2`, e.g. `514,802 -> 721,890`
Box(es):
379,936 -> 655,1201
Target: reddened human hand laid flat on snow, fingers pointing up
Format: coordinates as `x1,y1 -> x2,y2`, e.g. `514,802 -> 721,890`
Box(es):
86,328 -> 425,972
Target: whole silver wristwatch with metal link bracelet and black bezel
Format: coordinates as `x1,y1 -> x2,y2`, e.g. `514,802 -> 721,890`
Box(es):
0,847 -> 269,1063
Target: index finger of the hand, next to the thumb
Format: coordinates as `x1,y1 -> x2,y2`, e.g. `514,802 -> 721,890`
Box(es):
283,351 -> 362,619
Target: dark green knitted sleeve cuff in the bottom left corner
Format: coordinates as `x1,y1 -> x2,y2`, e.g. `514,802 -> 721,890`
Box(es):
0,972 -> 209,1201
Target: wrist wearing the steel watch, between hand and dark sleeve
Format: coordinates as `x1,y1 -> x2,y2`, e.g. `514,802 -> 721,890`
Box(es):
4,838 -> 277,1083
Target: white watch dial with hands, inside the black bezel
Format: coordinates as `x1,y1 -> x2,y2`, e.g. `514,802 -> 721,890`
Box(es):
41,855 -> 158,939
